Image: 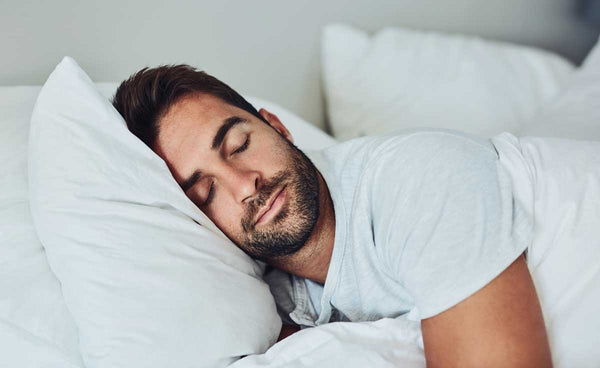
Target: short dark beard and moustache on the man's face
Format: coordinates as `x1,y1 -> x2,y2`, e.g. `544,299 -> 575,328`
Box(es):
233,137 -> 319,261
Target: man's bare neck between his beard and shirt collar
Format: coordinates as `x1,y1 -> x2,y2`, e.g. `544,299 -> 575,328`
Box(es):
269,173 -> 335,284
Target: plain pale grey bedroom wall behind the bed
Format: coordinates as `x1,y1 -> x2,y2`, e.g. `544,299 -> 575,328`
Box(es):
0,0 -> 598,131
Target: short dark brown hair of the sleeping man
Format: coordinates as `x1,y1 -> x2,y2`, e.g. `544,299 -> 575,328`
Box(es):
112,64 -> 267,150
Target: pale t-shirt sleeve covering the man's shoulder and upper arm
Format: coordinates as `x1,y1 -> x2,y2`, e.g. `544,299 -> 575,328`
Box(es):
369,133 -> 532,319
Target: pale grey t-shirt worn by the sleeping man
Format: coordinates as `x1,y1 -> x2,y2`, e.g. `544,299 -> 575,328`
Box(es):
265,128 -> 533,326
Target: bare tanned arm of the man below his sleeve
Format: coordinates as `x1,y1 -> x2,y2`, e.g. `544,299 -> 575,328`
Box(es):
421,256 -> 552,367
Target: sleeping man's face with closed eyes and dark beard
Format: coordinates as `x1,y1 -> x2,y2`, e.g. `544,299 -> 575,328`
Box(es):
154,94 -> 319,260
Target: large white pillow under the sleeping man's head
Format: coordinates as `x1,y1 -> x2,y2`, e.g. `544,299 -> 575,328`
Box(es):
29,57 -> 281,368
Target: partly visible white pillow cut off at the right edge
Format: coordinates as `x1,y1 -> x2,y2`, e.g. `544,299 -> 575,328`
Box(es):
520,39 -> 600,141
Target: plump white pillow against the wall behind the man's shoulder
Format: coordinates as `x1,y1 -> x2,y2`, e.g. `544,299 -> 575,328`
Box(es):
322,25 -> 573,139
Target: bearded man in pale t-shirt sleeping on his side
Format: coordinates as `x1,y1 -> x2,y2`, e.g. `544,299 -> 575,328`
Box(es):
113,65 -> 552,367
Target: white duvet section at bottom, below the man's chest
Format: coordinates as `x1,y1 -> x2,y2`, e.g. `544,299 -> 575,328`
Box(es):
230,316 -> 425,368
